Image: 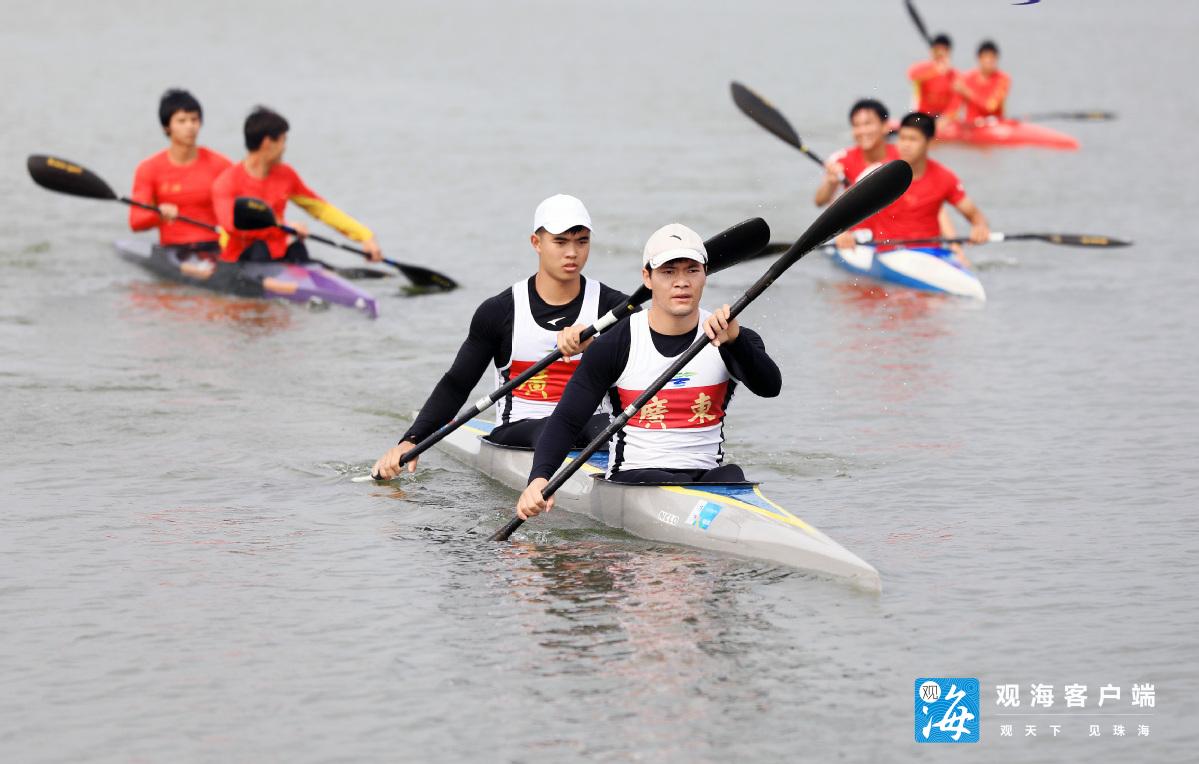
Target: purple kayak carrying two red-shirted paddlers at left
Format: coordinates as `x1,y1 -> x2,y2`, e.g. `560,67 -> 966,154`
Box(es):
114,240 -> 379,318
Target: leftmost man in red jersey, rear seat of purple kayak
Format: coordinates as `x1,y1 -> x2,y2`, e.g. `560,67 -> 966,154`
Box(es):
129,90 -> 231,252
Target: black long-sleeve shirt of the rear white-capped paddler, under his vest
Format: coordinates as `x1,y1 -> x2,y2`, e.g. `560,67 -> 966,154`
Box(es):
400,276 -> 628,443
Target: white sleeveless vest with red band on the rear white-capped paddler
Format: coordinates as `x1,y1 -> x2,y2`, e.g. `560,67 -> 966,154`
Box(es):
495,278 -> 610,425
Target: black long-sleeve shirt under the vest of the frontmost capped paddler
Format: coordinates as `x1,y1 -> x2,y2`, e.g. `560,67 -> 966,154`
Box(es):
529,321 -> 783,481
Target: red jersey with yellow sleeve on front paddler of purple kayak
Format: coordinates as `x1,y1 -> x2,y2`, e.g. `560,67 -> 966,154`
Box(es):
212,162 -> 374,263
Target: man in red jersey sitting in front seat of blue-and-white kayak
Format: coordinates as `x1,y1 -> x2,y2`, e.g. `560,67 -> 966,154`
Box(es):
870,112 -> 990,261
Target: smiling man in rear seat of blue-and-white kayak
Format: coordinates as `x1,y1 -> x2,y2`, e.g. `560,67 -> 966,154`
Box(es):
814,98 -> 954,249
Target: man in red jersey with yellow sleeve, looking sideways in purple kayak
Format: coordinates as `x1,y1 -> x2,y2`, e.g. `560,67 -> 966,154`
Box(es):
212,107 -> 382,263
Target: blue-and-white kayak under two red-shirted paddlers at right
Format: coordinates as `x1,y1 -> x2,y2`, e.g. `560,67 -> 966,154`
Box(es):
825,245 -> 987,300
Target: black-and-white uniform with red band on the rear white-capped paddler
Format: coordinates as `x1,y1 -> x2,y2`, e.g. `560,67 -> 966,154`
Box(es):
400,276 -> 628,446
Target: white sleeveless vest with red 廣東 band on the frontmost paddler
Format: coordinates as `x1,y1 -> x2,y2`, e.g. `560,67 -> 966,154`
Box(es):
608,311 -> 730,476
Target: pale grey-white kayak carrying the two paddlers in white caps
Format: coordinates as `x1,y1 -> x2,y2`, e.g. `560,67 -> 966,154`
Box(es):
438,419 -> 881,591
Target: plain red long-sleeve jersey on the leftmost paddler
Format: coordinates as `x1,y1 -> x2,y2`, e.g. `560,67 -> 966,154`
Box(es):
129,146 -> 233,245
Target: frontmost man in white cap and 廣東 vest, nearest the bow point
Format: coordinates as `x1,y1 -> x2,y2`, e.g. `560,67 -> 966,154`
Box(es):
517,223 -> 783,519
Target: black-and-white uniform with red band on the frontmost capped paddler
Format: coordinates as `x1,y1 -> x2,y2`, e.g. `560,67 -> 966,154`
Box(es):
529,311 -> 782,482
